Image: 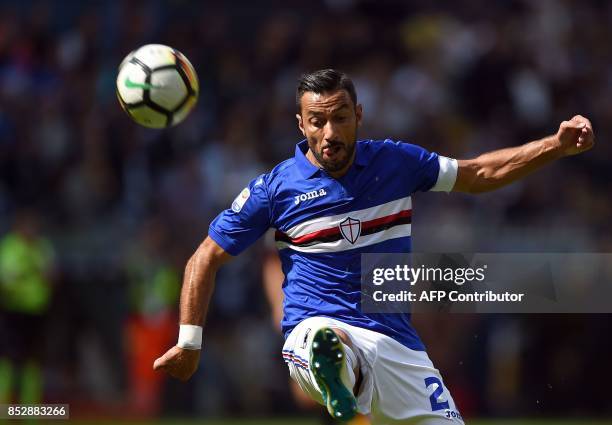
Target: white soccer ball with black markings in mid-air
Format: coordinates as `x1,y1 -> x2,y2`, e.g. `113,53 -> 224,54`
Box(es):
117,44 -> 199,128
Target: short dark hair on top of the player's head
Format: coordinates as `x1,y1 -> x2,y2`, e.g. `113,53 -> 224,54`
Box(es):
295,69 -> 357,114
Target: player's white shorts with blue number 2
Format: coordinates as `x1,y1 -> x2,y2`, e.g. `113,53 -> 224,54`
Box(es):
283,317 -> 463,425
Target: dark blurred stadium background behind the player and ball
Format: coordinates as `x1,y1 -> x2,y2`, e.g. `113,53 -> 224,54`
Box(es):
0,0 -> 612,423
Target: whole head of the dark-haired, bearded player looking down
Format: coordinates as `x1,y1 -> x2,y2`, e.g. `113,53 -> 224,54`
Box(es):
295,69 -> 363,175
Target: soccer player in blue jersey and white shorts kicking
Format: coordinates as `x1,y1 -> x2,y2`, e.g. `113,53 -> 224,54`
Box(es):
154,69 -> 594,425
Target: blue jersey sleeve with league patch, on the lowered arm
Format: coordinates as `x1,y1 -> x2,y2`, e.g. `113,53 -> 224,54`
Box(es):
208,176 -> 270,256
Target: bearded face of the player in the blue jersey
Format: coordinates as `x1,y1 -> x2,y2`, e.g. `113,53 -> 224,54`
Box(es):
296,90 -> 362,177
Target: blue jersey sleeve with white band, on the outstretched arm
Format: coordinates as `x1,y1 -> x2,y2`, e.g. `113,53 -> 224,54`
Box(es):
396,142 -> 457,192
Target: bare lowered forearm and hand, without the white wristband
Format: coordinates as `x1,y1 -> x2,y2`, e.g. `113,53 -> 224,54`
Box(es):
153,237 -> 231,381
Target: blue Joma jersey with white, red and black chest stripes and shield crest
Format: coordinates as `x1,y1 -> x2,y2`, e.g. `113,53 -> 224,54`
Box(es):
209,140 -> 443,350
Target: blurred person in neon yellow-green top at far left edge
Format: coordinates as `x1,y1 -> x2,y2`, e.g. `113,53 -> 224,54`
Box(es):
0,210 -> 54,404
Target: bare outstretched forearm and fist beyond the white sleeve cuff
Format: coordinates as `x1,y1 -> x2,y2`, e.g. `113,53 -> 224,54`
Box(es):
453,115 -> 595,193
